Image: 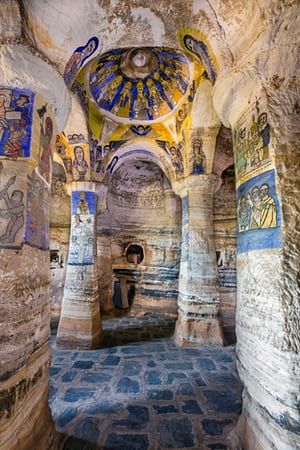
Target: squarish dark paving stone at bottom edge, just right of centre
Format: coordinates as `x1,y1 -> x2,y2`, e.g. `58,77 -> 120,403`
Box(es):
158,417 -> 195,448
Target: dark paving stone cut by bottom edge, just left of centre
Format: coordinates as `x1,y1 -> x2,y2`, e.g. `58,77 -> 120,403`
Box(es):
104,433 -> 149,450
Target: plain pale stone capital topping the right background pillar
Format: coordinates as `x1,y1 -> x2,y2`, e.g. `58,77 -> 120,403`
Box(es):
172,174 -> 216,198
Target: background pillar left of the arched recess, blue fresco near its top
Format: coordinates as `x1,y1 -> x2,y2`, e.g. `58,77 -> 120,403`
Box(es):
56,182 -> 102,349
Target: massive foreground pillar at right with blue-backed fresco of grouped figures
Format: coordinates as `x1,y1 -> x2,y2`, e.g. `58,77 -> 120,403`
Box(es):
216,65 -> 300,450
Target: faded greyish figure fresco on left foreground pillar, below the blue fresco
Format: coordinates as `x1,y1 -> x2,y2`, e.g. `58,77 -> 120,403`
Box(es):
0,176 -> 26,248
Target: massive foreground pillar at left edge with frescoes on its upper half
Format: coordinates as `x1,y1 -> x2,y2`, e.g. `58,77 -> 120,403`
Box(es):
0,45 -> 67,450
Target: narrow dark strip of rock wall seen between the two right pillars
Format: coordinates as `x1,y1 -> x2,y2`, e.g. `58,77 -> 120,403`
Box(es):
214,166 -> 237,344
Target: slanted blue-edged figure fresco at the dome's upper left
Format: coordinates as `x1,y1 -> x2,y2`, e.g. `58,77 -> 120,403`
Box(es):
64,36 -> 99,87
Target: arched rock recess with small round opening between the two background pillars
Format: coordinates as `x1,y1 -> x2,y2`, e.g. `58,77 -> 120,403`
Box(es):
97,160 -> 181,316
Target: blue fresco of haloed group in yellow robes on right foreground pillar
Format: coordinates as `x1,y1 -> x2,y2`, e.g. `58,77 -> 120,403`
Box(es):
237,170 -> 281,253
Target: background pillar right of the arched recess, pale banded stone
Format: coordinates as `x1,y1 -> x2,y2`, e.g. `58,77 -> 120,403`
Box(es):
173,175 -> 223,346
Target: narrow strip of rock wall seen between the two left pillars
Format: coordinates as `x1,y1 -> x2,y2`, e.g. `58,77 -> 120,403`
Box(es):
49,162 -> 71,318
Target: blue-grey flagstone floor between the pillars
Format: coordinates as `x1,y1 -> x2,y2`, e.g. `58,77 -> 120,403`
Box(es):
49,316 -> 241,450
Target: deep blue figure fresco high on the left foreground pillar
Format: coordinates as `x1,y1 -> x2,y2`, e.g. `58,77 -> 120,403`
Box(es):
0,86 -> 34,159
